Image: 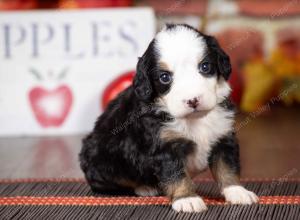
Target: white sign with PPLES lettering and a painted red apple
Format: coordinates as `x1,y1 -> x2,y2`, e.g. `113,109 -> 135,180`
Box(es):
0,8 -> 155,136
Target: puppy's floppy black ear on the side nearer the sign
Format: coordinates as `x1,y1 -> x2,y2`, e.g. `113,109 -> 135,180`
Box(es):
133,57 -> 152,101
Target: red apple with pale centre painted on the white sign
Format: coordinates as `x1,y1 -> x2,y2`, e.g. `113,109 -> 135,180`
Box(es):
29,85 -> 73,127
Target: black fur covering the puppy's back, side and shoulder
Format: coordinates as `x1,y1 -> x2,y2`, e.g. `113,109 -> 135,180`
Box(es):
80,87 -> 194,191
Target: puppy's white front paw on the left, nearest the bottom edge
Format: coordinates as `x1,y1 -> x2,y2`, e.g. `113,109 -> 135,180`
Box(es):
172,196 -> 207,212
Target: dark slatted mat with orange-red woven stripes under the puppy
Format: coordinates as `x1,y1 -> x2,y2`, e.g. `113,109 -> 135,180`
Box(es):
0,179 -> 300,220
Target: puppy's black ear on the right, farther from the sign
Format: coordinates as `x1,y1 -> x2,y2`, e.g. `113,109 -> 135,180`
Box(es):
207,36 -> 231,80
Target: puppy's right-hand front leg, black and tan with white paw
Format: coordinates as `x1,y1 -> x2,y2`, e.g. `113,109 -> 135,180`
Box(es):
209,134 -> 258,204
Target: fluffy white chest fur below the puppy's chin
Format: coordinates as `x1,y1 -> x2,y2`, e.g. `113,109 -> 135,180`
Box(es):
163,109 -> 233,175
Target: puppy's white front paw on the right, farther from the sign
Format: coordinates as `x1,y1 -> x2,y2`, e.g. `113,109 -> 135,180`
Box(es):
222,186 -> 259,205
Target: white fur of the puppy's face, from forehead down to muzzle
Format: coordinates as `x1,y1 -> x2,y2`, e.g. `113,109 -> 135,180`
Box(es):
155,25 -> 230,118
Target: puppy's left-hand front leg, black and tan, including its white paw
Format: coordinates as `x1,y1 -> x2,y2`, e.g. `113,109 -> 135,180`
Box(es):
157,138 -> 207,212
